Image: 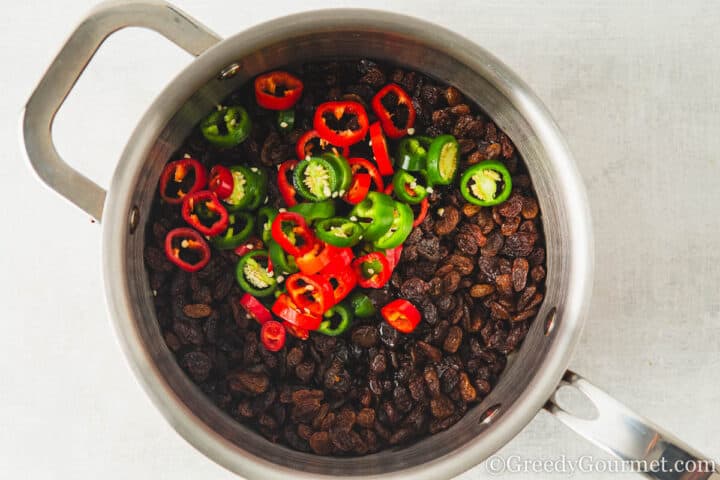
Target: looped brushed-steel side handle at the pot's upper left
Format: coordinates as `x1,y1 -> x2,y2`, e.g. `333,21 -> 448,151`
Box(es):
21,0 -> 220,221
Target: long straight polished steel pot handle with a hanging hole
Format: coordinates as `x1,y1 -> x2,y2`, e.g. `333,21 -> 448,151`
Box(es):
545,370 -> 720,480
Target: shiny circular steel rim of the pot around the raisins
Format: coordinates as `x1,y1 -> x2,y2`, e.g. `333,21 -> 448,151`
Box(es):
103,9 -> 593,479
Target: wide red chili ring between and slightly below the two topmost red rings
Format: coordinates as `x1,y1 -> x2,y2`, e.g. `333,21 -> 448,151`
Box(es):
313,101 -> 369,147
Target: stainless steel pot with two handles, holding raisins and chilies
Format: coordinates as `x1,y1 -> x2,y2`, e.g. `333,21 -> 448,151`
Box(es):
23,0 -> 719,480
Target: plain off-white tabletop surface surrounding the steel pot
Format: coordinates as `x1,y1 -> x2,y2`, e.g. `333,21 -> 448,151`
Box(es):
0,0 -> 720,480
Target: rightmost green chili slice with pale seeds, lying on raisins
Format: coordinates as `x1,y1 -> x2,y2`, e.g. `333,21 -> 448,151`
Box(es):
460,160 -> 512,207
